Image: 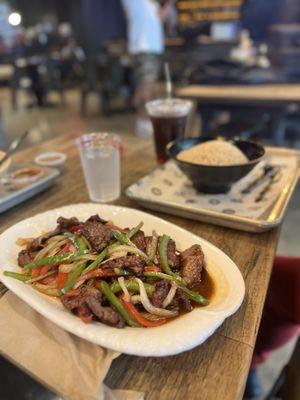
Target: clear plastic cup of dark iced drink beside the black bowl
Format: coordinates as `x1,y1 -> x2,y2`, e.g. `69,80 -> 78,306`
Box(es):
146,98 -> 192,164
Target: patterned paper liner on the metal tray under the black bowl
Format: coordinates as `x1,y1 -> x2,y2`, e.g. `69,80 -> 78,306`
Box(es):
127,154 -> 298,219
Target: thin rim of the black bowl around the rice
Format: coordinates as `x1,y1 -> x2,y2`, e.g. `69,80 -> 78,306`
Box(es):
166,136 -> 266,169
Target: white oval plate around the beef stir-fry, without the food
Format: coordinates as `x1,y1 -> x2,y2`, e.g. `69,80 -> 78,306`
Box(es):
0,204 -> 245,357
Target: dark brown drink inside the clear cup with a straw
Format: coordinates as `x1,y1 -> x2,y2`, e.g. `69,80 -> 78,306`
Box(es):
151,115 -> 187,164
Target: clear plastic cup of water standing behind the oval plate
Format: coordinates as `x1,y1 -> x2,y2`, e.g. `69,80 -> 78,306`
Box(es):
76,133 -> 120,203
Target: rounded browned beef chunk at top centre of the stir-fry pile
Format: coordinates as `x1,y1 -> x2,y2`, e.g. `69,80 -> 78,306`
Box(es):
82,220 -> 113,252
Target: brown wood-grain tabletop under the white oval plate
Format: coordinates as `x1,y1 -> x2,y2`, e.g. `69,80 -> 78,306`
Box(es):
0,136 -> 278,400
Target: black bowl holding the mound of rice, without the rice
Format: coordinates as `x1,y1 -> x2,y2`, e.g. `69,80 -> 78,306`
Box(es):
167,137 -> 265,194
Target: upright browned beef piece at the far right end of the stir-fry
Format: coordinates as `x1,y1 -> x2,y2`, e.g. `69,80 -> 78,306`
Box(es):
180,244 -> 205,289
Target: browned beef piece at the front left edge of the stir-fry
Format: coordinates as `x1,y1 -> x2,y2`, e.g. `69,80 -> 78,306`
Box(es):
61,285 -> 125,328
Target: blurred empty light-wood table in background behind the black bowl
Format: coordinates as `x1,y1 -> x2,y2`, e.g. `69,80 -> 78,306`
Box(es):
176,83 -> 300,145
